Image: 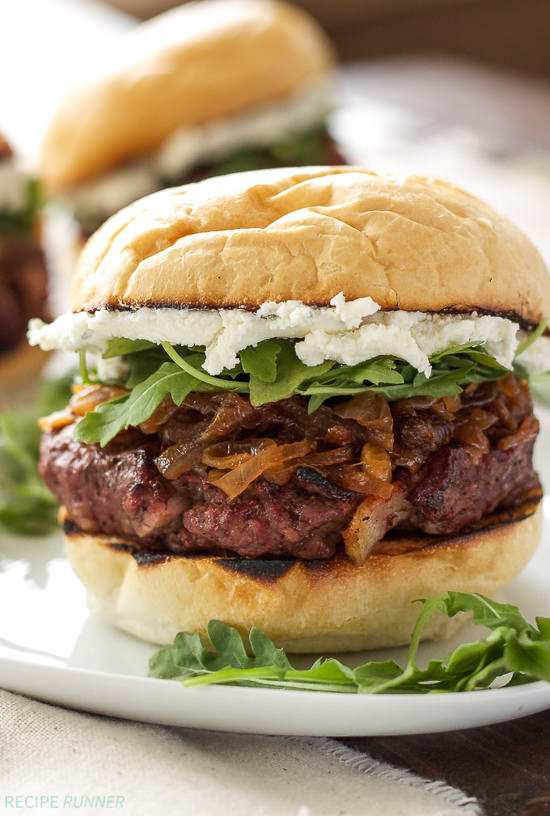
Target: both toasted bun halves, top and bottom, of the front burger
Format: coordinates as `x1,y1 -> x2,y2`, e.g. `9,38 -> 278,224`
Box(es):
42,167 -> 550,652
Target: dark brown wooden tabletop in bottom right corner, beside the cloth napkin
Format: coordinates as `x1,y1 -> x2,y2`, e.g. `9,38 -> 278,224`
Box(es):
340,711 -> 550,816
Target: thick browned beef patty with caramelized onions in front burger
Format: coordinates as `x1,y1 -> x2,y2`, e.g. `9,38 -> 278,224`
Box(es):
40,374 -> 539,559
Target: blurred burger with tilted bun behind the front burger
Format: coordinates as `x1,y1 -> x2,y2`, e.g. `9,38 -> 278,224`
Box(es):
41,0 -> 343,242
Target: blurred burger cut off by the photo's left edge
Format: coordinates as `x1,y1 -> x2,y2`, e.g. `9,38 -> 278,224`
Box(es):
0,134 -> 48,394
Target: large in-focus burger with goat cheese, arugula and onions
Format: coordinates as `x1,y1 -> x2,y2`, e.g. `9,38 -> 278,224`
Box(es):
29,167 -> 550,652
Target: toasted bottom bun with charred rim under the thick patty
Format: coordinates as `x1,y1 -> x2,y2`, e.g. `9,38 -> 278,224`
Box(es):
62,494 -> 542,653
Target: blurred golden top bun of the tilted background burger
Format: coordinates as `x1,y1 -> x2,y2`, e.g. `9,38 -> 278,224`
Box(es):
41,0 -> 333,190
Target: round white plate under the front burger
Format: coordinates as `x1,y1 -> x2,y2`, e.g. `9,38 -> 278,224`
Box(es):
0,406 -> 550,736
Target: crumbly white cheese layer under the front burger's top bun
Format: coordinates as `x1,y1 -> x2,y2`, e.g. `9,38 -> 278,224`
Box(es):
28,293 -> 550,376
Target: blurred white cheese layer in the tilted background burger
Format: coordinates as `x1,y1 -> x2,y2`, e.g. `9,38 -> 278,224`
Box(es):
70,78 -> 333,214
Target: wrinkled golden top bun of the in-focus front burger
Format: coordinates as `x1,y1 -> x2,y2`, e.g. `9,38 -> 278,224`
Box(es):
72,167 -> 550,325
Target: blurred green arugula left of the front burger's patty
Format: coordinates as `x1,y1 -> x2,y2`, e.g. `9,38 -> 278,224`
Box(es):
0,374 -> 73,535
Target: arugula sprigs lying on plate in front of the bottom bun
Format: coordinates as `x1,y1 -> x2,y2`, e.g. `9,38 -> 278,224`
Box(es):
149,592 -> 550,694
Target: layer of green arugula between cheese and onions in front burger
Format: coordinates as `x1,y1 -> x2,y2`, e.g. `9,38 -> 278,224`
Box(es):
75,328 -> 540,445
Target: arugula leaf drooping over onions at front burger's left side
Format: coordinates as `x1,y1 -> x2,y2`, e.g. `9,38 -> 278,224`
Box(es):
74,363 -> 198,447
